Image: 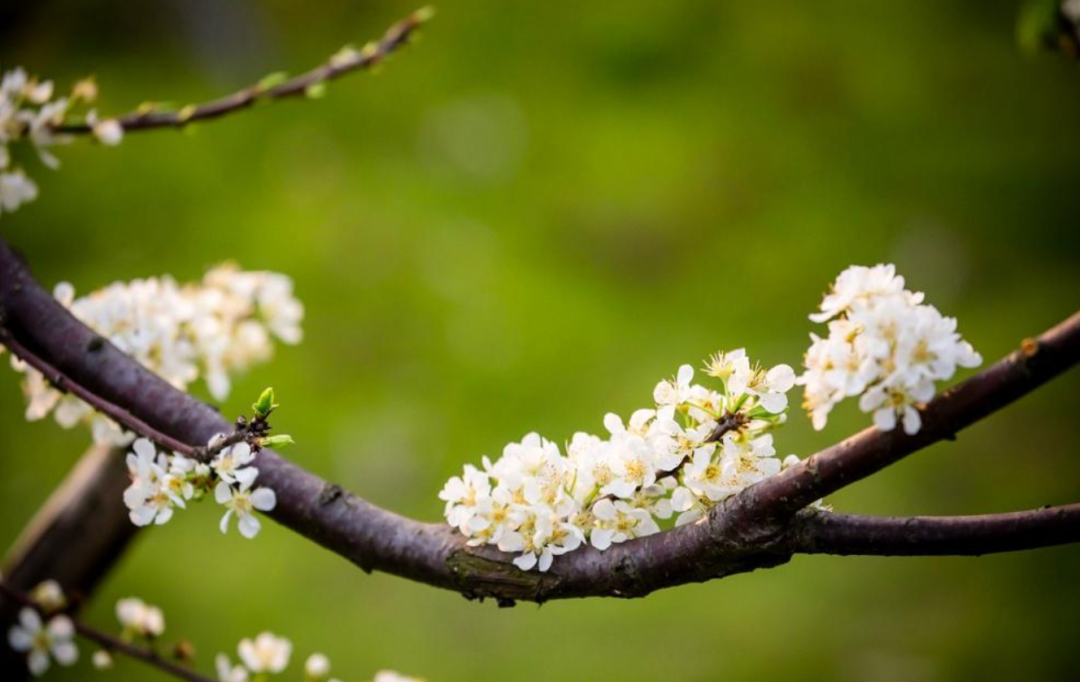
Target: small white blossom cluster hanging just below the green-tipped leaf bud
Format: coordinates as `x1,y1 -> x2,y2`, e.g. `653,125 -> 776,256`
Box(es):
124,436 -> 278,538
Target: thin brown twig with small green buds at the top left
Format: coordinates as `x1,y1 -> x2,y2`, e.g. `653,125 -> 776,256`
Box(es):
54,9 -> 431,134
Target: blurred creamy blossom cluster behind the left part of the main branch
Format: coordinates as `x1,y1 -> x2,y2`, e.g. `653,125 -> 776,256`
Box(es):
12,264 -> 303,445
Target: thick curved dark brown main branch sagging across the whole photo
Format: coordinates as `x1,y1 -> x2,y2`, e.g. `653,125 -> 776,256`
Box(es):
0,234 -> 1080,603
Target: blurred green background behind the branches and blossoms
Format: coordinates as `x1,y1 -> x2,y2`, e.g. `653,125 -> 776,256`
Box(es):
0,0 -> 1080,682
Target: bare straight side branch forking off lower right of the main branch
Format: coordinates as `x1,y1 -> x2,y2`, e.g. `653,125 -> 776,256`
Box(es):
787,504 -> 1080,557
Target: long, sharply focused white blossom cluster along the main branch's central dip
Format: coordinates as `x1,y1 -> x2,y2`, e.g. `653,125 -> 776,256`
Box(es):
440,349 -> 798,571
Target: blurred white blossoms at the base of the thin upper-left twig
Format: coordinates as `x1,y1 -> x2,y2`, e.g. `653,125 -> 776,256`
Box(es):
0,67 -> 124,214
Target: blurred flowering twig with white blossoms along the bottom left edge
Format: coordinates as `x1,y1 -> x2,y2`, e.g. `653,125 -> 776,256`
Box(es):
0,580 -> 422,682
